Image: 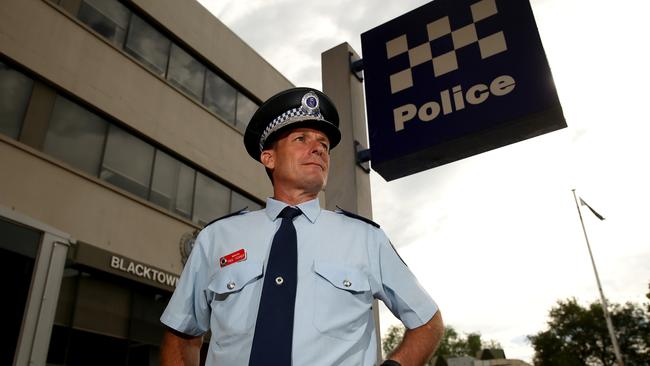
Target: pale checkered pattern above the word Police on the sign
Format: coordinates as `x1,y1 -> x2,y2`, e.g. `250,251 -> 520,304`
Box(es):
386,0 -> 508,94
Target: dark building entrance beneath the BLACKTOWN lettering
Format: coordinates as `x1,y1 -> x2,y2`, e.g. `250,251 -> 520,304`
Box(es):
47,264 -> 171,366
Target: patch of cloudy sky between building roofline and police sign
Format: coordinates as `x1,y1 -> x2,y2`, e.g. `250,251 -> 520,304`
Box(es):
199,0 -> 426,89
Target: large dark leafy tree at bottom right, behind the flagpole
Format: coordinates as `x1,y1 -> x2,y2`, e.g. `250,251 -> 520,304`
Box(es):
528,298 -> 650,366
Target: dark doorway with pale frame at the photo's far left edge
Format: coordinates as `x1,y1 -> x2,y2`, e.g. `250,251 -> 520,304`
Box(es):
0,205 -> 73,366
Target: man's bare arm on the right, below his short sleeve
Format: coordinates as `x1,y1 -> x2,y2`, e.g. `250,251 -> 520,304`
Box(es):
387,311 -> 444,366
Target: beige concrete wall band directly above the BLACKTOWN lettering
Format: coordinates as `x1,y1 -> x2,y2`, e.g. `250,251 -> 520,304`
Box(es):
0,135 -> 195,273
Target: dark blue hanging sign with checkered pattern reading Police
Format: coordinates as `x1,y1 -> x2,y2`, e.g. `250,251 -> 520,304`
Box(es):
361,0 -> 566,180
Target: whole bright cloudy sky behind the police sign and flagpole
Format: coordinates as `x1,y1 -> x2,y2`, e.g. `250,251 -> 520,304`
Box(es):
199,0 -> 650,362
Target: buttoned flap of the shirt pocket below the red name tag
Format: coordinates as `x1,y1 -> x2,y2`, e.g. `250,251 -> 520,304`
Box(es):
208,260 -> 264,294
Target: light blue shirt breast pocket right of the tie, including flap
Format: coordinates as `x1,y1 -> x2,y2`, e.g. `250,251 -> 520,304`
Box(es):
314,262 -> 372,340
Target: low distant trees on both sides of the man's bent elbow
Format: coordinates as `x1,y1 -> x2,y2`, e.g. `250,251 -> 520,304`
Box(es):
381,325 -> 501,364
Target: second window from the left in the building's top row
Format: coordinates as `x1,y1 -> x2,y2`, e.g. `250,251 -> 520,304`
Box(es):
125,14 -> 171,77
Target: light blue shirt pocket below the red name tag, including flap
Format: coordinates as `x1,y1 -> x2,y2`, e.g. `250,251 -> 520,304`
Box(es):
207,260 -> 263,342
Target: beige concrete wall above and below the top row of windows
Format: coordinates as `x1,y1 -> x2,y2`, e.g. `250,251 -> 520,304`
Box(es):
0,0 -> 291,199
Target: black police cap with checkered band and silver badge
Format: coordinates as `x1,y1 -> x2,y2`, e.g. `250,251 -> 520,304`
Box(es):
244,88 -> 341,161
